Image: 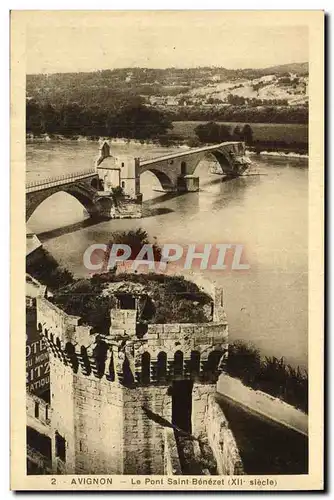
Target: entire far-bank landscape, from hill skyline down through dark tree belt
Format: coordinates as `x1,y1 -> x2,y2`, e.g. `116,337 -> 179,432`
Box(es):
26,64 -> 308,140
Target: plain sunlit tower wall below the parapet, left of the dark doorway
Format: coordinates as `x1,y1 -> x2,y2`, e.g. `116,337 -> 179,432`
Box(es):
46,357 -> 171,474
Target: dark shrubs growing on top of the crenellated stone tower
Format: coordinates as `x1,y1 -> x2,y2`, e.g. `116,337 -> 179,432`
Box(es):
51,272 -> 211,334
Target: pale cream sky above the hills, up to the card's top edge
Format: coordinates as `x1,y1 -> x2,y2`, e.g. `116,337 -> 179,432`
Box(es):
26,11 -> 308,74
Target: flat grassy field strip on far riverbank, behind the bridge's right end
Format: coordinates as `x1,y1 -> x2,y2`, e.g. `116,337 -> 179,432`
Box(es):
170,121 -> 308,144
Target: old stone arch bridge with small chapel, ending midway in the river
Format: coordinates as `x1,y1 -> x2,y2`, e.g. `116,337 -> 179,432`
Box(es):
26,141 -> 249,221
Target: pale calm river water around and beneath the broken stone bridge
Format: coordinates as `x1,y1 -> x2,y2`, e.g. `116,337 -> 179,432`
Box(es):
27,141 -> 308,368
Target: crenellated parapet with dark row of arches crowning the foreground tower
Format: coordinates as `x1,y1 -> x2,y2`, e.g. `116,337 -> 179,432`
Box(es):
37,274 -> 228,387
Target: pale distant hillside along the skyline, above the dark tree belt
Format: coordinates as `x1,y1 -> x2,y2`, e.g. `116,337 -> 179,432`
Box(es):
26,63 -> 308,108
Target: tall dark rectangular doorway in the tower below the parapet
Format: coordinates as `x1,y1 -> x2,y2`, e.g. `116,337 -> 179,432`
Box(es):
172,380 -> 193,434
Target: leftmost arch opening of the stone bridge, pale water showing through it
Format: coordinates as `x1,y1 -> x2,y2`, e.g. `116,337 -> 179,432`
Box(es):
27,191 -> 95,235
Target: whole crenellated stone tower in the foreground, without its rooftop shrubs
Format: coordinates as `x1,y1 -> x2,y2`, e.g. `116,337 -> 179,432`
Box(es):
37,278 -> 228,474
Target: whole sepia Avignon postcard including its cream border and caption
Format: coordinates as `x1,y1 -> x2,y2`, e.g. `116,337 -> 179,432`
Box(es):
11,11 -> 324,492
